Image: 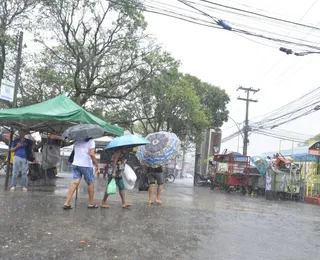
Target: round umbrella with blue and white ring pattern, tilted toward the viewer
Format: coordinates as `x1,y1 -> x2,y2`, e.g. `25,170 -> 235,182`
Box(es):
136,132 -> 180,168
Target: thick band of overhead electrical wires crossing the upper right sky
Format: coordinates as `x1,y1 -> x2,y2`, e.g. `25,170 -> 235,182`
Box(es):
131,0 -> 320,51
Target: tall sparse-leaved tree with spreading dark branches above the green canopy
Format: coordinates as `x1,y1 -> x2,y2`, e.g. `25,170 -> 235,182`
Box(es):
28,0 -> 166,105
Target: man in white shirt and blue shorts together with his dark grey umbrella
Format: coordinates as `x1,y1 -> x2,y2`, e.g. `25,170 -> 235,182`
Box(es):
61,125 -> 104,210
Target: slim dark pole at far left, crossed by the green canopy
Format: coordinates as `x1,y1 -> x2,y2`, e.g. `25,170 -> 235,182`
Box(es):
7,32 -> 23,176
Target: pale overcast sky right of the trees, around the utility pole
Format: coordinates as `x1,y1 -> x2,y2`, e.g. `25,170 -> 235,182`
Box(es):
146,0 -> 320,155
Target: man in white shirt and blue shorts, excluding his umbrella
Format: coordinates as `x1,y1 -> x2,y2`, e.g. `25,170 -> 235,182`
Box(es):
63,138 -> 99,209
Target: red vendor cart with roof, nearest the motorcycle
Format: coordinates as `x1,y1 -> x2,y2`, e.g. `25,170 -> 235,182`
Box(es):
214,153 -> 250,194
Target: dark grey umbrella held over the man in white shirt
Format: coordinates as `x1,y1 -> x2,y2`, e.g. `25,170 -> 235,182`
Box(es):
61,124 -> 104,140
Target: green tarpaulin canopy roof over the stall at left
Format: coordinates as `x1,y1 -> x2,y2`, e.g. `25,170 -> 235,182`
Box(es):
0,95 -> 124,136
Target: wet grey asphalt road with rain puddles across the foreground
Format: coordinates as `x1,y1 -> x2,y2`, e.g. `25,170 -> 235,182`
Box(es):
0,175 -> 320,260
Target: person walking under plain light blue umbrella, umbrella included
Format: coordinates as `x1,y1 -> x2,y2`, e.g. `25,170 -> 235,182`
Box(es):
101,135 -> 149,208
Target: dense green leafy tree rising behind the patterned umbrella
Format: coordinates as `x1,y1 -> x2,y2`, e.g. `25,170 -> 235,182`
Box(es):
101,64 -> 229,142
